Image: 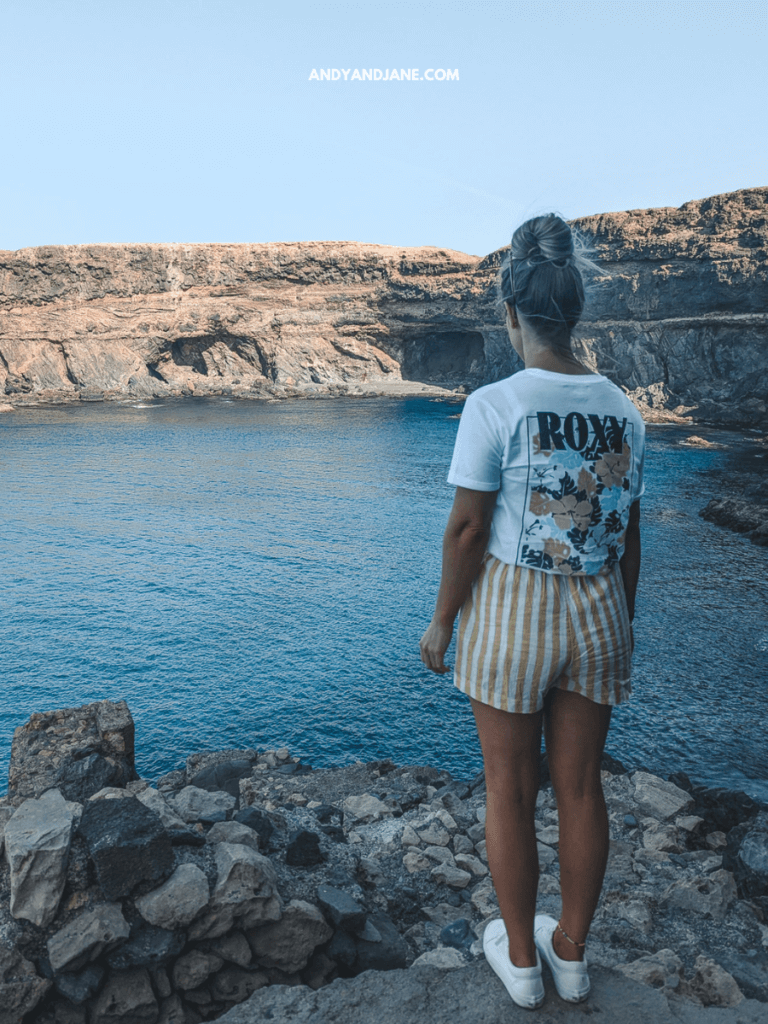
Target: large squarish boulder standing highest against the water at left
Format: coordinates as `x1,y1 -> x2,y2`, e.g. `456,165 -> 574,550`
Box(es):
8,700 -> 137,806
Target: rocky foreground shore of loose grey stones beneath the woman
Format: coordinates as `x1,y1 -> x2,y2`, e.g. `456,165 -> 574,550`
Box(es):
0,700 -> 768,1024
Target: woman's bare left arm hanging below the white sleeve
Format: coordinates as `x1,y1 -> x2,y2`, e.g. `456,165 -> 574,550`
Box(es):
419,487 -> 499,673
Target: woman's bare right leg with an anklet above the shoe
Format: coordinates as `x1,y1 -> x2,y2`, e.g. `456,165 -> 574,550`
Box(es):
544,687 -> 611,959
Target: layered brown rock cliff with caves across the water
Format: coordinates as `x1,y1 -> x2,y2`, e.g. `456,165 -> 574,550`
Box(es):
0,187 -> 768,425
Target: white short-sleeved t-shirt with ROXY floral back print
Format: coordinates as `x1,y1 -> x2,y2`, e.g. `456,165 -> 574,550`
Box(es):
447,369 -> 645,575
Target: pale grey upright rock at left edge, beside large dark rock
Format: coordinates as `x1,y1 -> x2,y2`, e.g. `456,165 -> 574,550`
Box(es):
5,790 -> 74,928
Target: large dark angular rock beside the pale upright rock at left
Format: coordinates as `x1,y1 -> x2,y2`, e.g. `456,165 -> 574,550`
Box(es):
78,797 -> 173,900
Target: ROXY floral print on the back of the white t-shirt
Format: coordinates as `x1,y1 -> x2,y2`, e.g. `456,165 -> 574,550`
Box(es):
517,410 -> 634,575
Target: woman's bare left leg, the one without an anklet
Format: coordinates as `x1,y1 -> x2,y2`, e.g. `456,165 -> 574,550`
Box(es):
469,697 -> 543,967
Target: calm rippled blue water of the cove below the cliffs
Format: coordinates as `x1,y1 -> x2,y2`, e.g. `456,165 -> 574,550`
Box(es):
0,398 -> 768,799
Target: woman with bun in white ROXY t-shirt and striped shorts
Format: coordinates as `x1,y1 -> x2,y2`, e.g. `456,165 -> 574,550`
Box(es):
420,214 -> 645,1008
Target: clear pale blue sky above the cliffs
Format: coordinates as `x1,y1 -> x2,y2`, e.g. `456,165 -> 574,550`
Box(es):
0,0 -> 768,255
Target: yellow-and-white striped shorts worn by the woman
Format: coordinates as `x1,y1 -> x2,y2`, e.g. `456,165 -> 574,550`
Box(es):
454,552 -> 632,714
